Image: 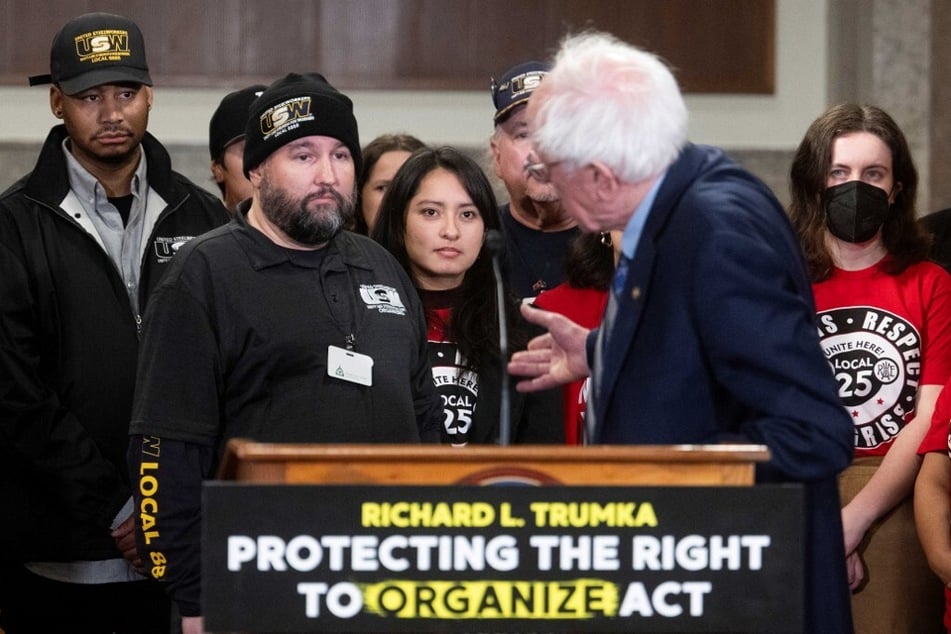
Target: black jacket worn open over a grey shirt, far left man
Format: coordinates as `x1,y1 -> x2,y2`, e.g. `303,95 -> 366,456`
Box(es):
0,126 -> 228,561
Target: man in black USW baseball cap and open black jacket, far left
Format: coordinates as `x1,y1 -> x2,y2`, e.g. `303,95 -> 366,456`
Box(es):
0,13 -> 228,634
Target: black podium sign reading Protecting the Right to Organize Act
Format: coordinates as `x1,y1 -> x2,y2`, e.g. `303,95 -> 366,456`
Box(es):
202,482 -> 803,632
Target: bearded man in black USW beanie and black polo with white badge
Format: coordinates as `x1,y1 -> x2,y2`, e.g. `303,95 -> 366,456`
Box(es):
128,74 -> 442,634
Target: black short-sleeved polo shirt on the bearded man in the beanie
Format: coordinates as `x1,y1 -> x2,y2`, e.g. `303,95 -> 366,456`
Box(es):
131,207 -> 439,455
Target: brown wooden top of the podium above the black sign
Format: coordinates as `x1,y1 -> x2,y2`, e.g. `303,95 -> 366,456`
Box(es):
219,439 -> 769,486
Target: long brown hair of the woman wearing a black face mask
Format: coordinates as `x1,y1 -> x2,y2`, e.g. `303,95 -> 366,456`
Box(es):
789,104 -> 931,282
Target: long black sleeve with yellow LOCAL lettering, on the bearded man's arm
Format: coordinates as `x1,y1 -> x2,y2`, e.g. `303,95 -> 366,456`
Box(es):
128,436 -> 214,616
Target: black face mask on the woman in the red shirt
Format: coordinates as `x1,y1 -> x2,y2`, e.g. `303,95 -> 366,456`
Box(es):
822,181 -> 890,242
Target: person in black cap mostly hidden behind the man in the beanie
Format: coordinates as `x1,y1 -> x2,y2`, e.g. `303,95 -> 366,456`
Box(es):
208,85 -> 267,212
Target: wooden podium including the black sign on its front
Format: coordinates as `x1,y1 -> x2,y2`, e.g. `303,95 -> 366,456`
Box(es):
202,439 -> 804,633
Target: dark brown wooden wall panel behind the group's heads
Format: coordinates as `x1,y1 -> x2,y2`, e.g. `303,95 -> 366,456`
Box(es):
0,0 -> 776,94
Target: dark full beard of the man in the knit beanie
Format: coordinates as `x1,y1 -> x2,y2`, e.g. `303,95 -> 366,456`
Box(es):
259,176 -> 355,245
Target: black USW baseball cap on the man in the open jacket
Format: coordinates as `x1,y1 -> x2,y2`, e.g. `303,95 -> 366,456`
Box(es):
30,13 -> 152,95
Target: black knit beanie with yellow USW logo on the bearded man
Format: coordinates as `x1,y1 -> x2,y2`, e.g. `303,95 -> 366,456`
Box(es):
244,73 -> 362,176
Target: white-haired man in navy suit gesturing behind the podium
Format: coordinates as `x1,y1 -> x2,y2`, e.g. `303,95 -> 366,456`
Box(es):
509,33 -> 853,632
